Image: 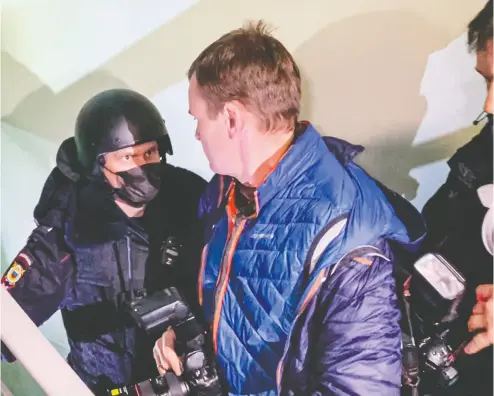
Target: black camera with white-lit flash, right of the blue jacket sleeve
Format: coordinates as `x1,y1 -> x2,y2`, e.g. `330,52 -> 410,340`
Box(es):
403,253 -> 474,392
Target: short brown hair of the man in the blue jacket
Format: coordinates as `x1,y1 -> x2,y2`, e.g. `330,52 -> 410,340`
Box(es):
188,21 -> 301,130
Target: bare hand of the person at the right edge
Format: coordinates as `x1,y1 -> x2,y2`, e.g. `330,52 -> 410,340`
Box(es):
465,285 -> 494,354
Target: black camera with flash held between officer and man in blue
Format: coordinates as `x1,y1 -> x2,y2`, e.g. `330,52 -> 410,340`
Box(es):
107,238 -> 223,396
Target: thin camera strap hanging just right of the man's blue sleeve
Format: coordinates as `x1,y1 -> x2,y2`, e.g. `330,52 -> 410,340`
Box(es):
402,277 -> 420,396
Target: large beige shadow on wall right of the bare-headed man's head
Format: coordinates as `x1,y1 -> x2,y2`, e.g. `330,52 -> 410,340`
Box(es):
295,11 -> 476,199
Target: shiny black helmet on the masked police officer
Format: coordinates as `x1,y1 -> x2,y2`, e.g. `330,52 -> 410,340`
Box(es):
75,89 -> 173,176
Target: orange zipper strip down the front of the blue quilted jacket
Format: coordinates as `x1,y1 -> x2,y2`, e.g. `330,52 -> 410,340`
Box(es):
213,216 -> 247,353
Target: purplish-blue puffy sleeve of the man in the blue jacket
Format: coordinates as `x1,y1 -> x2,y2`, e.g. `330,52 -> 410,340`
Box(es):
306,243 -> 402,396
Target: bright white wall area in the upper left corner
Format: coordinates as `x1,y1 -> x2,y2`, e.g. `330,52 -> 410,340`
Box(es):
2,0 -> 197,92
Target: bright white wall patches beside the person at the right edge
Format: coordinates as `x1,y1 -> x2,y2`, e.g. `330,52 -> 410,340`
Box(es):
410,33 -> 487,209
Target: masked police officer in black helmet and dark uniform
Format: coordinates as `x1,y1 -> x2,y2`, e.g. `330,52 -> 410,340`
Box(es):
2,89 -> 205,394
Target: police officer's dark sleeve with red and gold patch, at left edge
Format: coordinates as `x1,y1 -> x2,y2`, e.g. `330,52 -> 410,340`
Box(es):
1,225 -> 74,361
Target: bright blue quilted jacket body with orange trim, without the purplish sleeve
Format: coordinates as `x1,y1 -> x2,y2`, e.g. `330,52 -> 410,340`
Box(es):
198,125 -> 407,396
